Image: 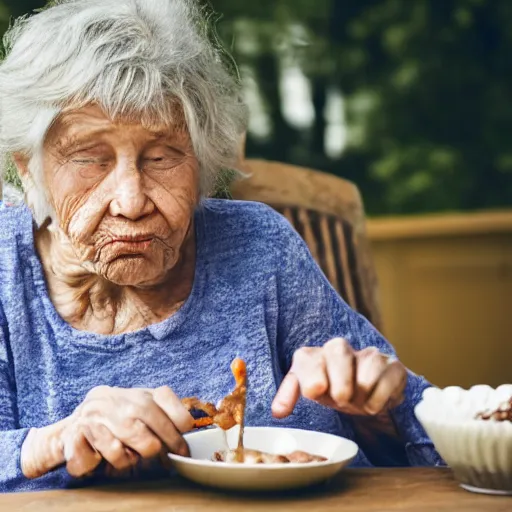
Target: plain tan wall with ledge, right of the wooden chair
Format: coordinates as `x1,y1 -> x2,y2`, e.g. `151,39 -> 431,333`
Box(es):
368,211 -> 512,386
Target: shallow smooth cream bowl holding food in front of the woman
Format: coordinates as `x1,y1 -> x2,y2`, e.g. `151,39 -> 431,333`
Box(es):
169,427 -> 358,491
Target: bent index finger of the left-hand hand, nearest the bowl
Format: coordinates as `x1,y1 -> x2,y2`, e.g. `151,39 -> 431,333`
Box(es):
152,386 -> 194,457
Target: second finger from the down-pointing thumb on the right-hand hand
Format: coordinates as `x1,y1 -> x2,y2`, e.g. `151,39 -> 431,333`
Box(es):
323,338 -> 355,408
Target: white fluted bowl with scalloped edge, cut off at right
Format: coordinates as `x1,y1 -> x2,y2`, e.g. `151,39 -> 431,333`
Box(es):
415,384 -> 512,495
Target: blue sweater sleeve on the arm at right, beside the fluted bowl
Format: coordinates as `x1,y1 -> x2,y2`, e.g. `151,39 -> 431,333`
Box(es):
276,219 -> 443,466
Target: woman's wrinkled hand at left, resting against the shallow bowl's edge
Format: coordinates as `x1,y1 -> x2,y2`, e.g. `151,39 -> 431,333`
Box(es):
21,386 -> 193,478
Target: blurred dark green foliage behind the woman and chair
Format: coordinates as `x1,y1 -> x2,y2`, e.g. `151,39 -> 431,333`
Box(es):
0,0 -> 512,214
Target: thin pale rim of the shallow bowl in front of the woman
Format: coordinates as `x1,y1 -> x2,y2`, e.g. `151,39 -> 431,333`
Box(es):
167,426 -> 359,471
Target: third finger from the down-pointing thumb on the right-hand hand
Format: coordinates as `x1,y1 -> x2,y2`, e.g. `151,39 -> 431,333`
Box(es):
352,347 -> 388,408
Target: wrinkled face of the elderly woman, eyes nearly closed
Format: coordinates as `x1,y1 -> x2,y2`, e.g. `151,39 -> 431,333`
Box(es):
44,106 -> 199,286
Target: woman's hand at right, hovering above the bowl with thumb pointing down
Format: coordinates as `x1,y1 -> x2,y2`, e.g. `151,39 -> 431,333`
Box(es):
272,338 -> 407,418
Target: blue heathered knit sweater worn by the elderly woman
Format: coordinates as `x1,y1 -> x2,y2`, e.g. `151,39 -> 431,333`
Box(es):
0,200 -> 440,492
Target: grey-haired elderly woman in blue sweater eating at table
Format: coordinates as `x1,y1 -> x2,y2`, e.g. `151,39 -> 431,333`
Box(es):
0,0 -> 441,492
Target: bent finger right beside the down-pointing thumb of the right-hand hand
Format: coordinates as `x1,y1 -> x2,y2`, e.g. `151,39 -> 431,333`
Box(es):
290,347 -> 329,400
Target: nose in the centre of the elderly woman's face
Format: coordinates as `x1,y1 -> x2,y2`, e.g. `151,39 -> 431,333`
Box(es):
110,165 -> 155,220
